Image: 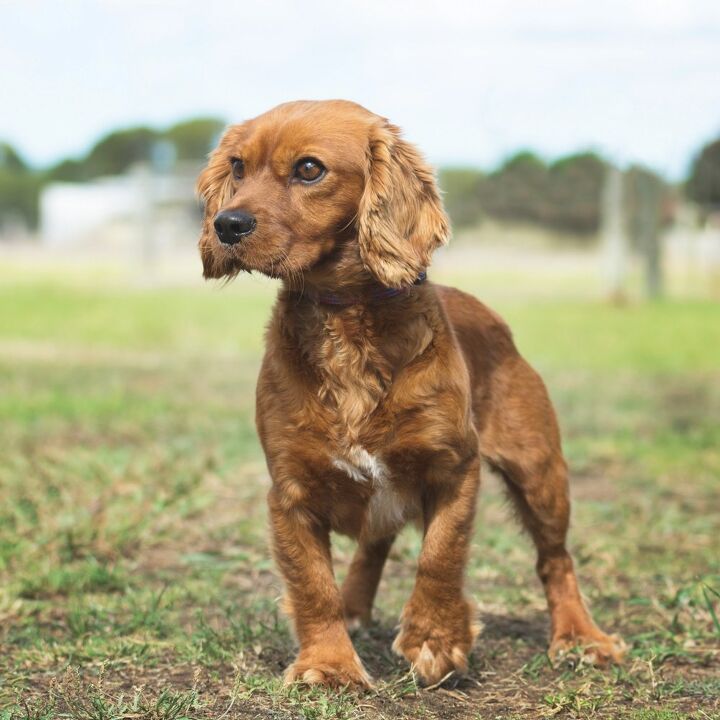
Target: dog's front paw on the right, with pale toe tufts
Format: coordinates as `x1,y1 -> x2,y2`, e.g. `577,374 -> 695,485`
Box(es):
393,600 -> 478,685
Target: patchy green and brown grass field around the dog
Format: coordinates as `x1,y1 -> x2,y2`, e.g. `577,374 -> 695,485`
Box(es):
0,260 -> 720,720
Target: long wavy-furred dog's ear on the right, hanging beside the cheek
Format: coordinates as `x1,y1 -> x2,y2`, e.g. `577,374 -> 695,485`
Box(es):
357,120 -> 450,288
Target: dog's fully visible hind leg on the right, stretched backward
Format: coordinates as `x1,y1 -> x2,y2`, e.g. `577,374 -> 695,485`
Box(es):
480,358 -> 625,665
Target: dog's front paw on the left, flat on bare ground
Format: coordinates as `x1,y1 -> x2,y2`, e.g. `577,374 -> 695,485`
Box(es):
285,647 -> 372,688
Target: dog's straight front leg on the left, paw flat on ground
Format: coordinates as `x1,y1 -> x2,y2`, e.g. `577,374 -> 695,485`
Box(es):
268,486 -> 370,687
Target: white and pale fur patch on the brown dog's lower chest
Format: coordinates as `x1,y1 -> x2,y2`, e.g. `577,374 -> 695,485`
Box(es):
332,445 -> 419,539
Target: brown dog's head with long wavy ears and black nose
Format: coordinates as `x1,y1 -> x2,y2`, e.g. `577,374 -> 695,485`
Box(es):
198,100 -> 449,288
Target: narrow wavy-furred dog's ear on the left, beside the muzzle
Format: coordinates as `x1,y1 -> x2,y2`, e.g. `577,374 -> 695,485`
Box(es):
196,128 -> 233,278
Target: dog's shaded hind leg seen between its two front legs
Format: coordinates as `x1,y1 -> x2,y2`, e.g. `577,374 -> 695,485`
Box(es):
342,536 -> 395,630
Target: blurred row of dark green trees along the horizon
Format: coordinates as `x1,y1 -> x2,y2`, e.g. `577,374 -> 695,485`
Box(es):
0,117 -> 720,232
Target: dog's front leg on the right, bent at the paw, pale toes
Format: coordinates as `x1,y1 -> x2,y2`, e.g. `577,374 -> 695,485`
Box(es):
393,453 -> 480,684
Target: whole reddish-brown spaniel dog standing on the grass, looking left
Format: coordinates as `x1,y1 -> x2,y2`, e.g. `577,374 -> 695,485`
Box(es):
198,101 -> 623,685
